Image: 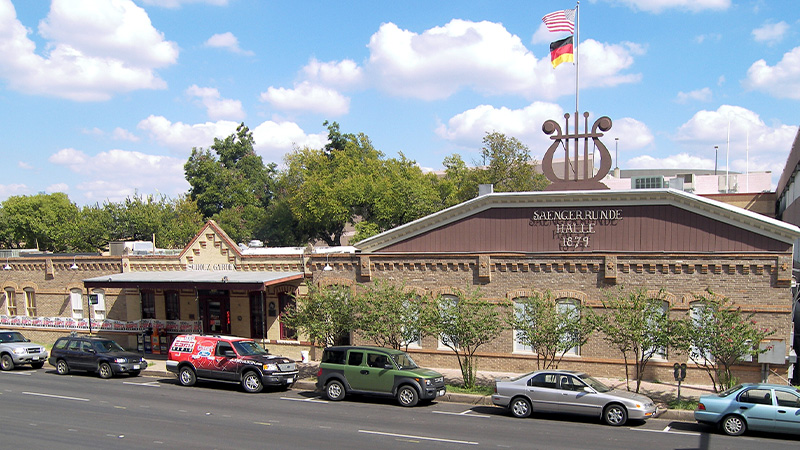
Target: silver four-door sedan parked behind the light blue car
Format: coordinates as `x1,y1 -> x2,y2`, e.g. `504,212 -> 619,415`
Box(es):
492,370 -> 656,426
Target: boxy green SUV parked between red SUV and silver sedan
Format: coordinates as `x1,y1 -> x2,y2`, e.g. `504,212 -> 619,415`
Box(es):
317,346 -> 446,406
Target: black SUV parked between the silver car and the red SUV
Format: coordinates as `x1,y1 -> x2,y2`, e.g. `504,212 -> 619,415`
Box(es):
47,336 -> 147,378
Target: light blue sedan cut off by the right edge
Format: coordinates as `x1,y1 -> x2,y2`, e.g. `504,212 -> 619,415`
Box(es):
694,383 -> 800,436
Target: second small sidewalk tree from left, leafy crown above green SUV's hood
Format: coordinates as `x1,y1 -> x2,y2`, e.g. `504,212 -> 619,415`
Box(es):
357,280 -> 422,350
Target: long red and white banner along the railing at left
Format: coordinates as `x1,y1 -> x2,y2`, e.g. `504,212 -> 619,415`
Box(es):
0,316 -> 201,334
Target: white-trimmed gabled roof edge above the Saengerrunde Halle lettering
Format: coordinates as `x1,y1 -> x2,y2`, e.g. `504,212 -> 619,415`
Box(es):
355,189 -> 800,252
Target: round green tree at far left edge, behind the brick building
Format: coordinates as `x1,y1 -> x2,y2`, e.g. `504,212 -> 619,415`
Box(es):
0,192 -> 80,252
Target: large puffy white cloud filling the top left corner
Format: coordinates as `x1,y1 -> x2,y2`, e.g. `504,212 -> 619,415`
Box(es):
0,0 -> 178,101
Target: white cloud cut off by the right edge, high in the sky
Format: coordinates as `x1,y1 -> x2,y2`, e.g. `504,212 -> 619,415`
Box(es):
743,47 -> 800,100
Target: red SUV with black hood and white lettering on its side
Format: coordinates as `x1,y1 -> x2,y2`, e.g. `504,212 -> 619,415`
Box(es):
167,334 -> 298,393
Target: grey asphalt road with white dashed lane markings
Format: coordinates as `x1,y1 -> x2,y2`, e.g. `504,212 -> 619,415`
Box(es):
0,366 -> 800,450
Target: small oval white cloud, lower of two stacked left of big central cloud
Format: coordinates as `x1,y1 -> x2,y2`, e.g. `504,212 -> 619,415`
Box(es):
259,81 -> 350,116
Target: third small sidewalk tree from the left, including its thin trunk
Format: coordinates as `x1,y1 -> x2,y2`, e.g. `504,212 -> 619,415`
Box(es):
422,289 -> 503,389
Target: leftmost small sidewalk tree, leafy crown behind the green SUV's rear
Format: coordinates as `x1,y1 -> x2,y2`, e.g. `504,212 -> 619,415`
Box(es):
280,285 -> 358,347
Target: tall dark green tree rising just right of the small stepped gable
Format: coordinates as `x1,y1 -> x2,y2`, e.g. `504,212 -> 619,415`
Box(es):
184,124 -> 276,240
